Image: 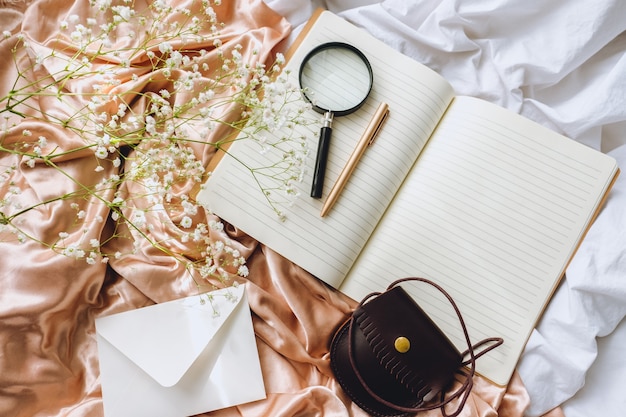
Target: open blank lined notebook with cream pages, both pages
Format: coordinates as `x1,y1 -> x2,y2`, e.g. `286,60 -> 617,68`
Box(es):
198,12 -> 618,385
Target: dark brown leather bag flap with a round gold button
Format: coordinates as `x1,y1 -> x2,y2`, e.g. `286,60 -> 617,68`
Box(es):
354,286 -> 462,404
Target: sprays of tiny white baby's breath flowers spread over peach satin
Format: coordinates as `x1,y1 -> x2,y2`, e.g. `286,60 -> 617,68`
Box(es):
0,0 -> 318,285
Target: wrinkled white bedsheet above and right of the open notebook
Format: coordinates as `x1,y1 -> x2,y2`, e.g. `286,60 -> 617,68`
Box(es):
266,0 -> 626,417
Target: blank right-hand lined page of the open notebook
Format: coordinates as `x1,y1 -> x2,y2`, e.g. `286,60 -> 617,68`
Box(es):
340,98 -> 616,385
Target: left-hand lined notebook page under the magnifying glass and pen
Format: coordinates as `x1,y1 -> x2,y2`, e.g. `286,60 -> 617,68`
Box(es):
198,13 -> 453,287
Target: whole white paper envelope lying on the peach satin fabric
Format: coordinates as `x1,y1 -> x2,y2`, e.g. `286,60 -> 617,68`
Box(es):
96,285 -> 265,417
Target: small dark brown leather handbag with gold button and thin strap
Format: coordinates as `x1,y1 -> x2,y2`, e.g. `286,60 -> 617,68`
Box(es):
330,277 -> 503,417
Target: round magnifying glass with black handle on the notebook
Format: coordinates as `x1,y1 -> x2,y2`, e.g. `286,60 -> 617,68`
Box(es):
299,42 -> 373,198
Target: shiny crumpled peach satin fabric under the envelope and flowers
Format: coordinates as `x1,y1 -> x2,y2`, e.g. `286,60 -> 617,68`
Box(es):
0,0 -> 552,417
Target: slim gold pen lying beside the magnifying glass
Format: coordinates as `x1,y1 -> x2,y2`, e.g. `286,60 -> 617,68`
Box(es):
320,102 -> 389,217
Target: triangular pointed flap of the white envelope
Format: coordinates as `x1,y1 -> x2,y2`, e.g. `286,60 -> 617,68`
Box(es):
96,285 -> 247,387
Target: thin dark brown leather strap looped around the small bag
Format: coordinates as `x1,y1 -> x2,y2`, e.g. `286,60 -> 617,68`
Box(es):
348,277 -> 504,417
